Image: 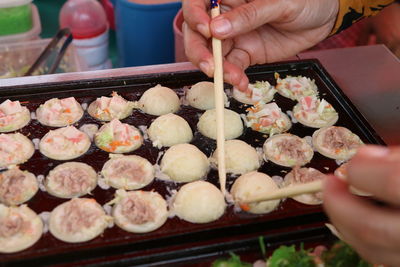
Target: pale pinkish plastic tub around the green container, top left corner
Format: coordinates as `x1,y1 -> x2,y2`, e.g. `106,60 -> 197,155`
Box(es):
0,4 -> 42,44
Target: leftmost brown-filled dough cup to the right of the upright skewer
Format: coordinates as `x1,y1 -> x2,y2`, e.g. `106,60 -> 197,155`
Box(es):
263,134 -> 314,167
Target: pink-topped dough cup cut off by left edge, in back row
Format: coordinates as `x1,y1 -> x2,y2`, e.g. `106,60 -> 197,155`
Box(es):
0,99 -> 31,133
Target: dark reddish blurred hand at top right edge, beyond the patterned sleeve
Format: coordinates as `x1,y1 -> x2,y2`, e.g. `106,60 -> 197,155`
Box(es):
370,3 -> 400,57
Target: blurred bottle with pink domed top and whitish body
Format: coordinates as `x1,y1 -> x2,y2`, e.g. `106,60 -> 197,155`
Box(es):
60,0 -> 108,69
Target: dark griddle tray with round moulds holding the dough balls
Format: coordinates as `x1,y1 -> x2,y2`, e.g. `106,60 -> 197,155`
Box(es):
0,60 -> 383,265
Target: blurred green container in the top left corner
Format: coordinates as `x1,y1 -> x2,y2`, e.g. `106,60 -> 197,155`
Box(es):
0,0 -> 32,36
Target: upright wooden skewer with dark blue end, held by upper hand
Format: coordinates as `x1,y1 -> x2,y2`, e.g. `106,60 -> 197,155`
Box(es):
211,1 -> 226,195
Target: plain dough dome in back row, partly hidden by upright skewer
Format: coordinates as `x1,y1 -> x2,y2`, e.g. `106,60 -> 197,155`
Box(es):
186,82 -> 229,110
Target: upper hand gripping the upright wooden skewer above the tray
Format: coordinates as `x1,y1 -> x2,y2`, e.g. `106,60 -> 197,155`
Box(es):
183,0 -> 339,91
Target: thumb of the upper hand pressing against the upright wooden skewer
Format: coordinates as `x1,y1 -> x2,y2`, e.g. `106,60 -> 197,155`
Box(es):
210,0 -> 290,39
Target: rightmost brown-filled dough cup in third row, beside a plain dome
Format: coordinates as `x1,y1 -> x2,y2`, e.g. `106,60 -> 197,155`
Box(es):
101,155 -> 154,190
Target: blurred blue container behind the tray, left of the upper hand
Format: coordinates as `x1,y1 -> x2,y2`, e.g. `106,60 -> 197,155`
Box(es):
115,0 -> 182,67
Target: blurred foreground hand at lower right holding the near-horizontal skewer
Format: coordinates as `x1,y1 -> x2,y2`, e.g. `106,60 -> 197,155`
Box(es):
323,145 -> 400,266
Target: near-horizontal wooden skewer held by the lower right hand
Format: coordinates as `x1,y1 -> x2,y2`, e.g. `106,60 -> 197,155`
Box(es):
240,180 -> 322,203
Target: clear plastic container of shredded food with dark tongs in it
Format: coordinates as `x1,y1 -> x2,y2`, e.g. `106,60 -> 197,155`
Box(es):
0,39 -> 88,79
